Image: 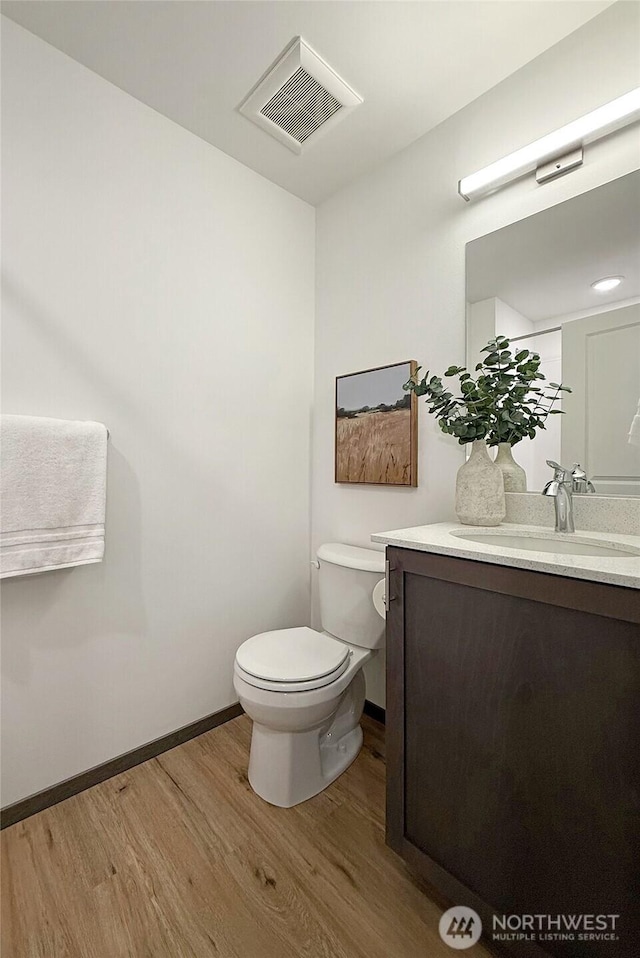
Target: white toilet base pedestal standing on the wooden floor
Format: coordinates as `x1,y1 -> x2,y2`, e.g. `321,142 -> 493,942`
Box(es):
249,722 -> 362,808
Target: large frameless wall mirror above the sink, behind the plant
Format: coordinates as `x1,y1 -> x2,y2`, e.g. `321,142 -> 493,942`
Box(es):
466,171 -> 640,496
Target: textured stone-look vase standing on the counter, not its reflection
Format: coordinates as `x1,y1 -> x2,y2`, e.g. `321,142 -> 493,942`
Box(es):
456,439 -> 506,526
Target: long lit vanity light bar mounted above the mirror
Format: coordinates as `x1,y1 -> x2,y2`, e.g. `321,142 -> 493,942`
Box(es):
458,87 -> 640,200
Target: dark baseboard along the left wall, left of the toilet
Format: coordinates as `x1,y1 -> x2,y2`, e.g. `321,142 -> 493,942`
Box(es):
0,704 -> 242,828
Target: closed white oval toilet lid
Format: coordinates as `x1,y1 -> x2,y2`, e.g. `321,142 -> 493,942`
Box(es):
236,628 -> 349,682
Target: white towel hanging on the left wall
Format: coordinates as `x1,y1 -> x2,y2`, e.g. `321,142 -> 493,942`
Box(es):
0,416 -> 107,578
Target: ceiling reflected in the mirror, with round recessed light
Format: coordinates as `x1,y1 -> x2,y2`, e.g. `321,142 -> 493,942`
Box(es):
467,172 -> 640,322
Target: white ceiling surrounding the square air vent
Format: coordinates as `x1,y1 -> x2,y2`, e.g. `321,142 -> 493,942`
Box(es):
1,0 -> 610,204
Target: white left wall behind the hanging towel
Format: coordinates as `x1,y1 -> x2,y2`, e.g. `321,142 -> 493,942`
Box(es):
2,18 -> 314,804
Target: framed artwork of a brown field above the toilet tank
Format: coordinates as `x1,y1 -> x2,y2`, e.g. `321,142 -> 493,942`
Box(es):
335,360 -> 418,486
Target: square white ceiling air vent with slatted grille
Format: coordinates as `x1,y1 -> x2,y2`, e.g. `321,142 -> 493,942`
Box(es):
239,37 -> 362,153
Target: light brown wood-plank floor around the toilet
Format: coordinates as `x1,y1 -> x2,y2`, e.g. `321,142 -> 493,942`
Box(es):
2,716 -> 488,958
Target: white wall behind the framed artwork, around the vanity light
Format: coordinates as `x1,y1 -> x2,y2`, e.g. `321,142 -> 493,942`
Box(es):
312,3 -> 640,704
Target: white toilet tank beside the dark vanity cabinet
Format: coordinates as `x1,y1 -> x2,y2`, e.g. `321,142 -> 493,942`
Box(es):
317,542 -> 385,649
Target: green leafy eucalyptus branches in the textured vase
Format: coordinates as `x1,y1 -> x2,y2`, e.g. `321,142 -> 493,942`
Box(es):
403,336 -> 571,446
